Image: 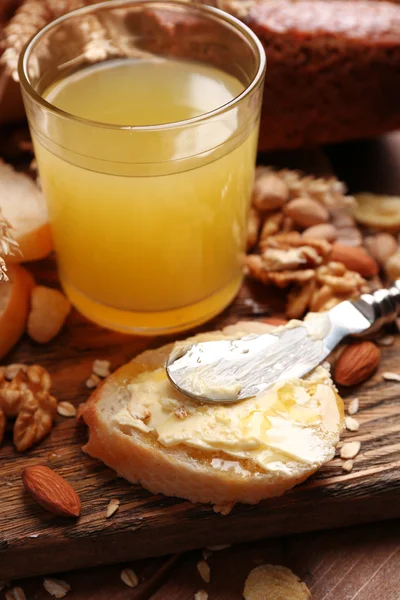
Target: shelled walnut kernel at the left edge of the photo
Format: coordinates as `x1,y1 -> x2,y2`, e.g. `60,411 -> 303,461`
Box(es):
0,365 -> 57,452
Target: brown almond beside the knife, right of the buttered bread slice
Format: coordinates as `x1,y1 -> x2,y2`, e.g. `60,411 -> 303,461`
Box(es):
334,341 -> 381,386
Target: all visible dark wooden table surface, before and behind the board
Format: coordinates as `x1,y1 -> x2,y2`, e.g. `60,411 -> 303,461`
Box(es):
0,134 -> 400,600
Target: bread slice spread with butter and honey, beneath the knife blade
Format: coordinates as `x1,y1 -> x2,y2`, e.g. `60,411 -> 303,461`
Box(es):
81,323 -> 343,505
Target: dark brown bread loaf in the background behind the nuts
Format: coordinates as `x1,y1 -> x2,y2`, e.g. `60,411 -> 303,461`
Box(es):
243,0 -> 400,150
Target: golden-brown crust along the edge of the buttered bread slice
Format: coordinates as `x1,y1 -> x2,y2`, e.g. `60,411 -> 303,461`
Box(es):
79,330 -> 343,507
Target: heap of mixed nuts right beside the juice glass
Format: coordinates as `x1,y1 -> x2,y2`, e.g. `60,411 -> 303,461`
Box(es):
245,167 -> 382,318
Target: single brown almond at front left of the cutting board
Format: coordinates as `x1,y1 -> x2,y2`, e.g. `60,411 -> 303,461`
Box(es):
22,465 -> 81,517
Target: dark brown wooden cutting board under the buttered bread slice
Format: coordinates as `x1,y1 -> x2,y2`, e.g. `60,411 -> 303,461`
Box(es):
0,145 -> 400,580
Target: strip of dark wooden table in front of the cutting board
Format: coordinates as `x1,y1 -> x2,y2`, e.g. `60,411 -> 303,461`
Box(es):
0,521 -> 400,600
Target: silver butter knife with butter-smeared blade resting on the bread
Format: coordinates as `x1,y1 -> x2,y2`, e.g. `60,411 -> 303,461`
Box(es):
166,280 -> 400,403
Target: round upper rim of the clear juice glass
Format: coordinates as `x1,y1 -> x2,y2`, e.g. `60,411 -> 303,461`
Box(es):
18,0 -> 267,132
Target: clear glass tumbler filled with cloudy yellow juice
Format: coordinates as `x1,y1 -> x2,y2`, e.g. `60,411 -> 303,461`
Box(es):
19,0 -> 265,335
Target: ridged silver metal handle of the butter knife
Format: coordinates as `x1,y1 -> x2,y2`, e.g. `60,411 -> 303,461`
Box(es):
352,279 -> 400,333
